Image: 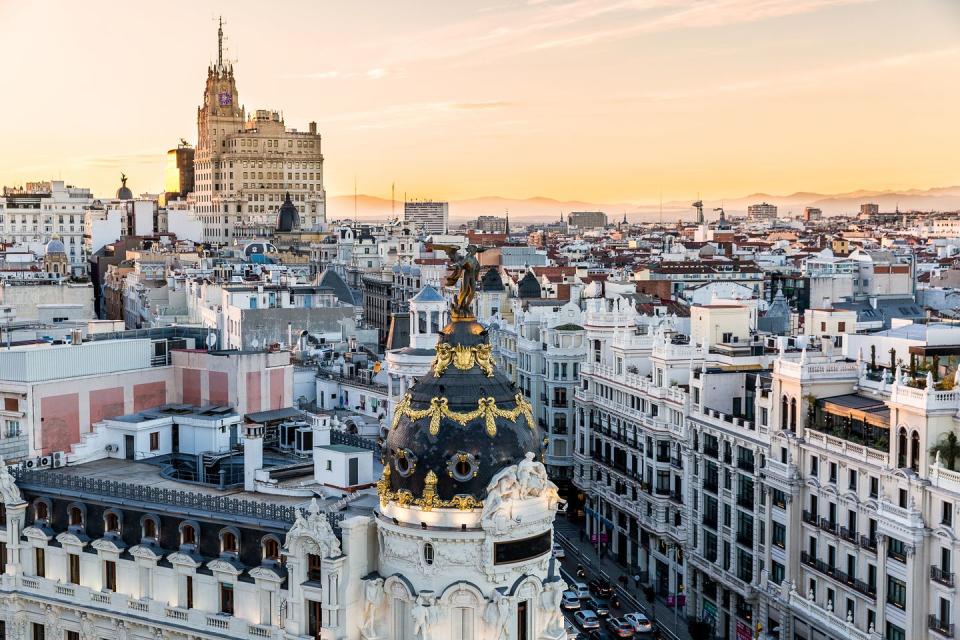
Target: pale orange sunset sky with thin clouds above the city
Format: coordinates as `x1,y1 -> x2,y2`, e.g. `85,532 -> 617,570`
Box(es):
0,0 -> 960,203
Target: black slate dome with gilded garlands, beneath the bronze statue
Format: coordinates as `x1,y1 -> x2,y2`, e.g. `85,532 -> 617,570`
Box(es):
379,318 -> 544,508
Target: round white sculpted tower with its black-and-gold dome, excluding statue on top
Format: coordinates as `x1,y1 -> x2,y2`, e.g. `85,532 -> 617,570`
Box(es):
361,300 -> 565,640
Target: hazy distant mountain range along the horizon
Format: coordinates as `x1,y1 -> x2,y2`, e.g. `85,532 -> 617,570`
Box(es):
327,186 -> 960,223
